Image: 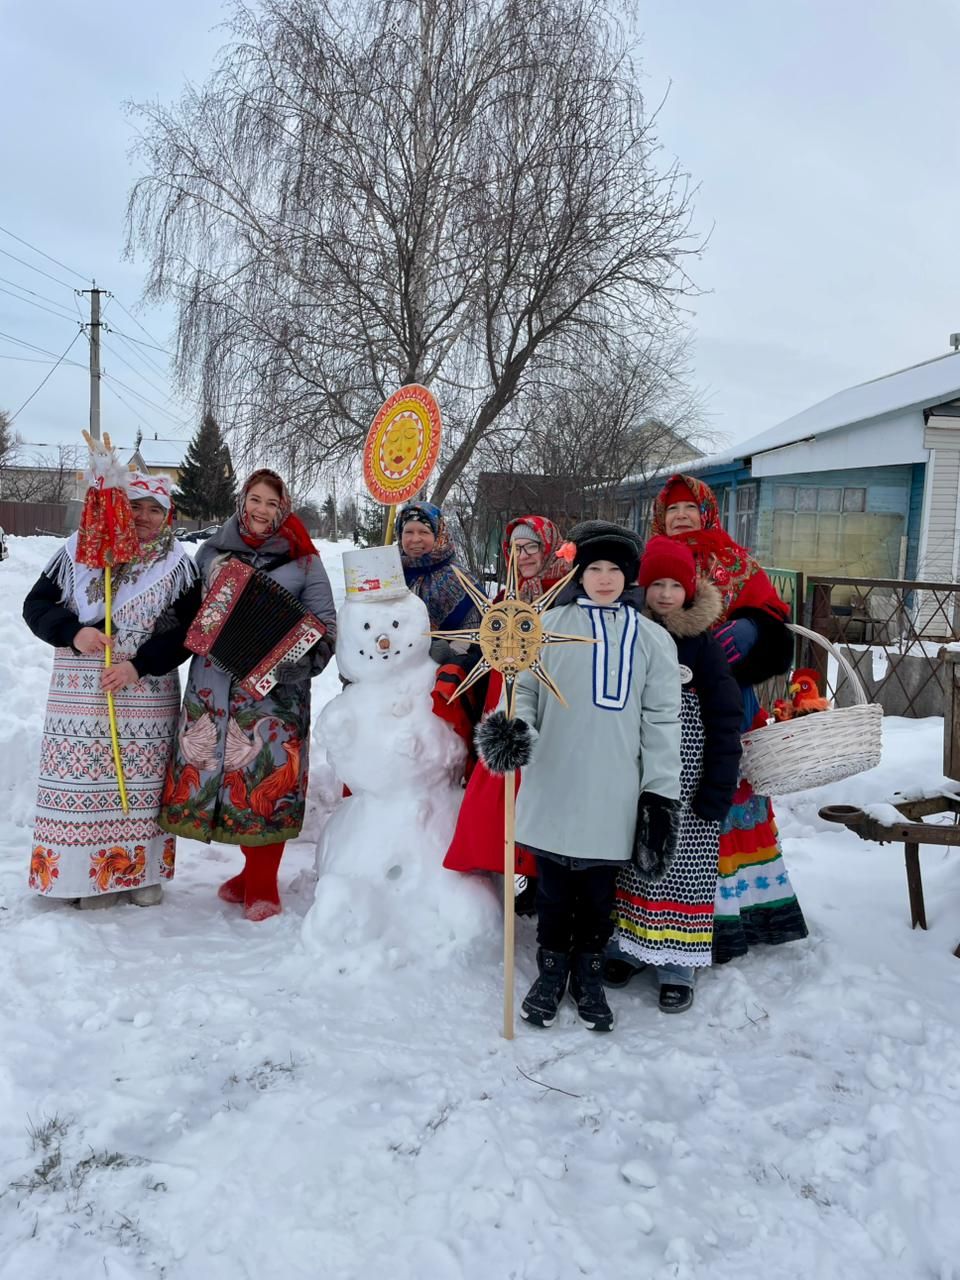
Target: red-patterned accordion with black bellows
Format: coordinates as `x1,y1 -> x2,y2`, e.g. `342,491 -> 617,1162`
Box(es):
184,559 -> 326,698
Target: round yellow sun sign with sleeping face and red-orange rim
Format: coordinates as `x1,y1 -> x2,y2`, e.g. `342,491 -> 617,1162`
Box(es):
364,383 -> 443,547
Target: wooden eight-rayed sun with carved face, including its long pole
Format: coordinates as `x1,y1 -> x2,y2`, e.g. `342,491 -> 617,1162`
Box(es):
430,543 -> 596,1039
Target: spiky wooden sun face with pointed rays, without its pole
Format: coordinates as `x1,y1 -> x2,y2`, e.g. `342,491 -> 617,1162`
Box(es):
430,547 -> 596,716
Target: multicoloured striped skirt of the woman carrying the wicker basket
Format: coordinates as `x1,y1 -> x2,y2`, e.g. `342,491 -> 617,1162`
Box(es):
713,780 -> 806,964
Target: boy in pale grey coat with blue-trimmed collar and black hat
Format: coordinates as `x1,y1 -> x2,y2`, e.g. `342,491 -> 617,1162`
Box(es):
477,521 -> 680,1030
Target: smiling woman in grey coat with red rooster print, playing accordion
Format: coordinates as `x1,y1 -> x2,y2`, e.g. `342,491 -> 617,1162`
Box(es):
160,470 -> 337,920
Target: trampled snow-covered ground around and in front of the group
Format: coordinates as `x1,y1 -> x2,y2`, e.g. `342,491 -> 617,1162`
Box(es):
0,538 -> 960,1280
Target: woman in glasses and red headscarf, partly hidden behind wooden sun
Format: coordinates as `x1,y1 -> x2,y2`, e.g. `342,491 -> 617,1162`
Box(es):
434,516 -> 570,914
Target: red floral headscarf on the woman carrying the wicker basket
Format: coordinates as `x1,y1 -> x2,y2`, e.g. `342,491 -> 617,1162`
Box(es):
650,475 -> 790,622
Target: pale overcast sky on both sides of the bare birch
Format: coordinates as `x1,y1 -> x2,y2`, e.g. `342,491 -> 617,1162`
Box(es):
0,0 -> 960,471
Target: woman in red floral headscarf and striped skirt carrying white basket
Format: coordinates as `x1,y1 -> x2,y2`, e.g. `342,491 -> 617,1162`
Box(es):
652,475 -> 806,964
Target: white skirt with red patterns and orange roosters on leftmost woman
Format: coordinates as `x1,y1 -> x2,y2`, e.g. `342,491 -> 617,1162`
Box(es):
29,649 -> 180,897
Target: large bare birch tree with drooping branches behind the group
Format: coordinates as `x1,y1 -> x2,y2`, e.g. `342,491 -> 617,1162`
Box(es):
129,0 -> 698,500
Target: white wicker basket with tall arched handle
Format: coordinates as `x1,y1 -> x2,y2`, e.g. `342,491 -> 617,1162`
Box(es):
740,623 -> 883,796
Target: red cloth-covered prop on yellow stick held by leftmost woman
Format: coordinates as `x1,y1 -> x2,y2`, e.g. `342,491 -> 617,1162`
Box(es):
77,431 -> 140,813
